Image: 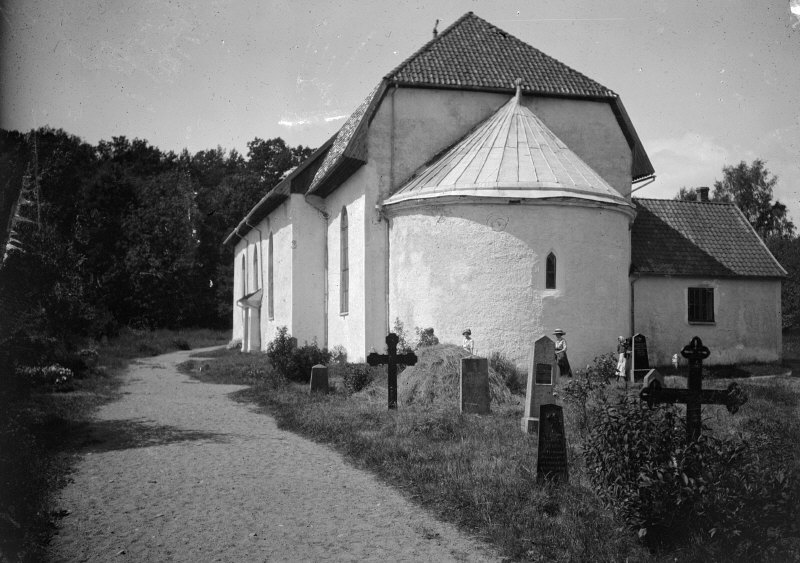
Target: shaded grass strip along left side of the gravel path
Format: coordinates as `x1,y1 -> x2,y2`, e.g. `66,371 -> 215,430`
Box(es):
0,329 -> 230,562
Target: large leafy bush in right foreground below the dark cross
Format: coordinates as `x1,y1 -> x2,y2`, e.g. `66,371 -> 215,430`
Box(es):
584,397 -> 800,560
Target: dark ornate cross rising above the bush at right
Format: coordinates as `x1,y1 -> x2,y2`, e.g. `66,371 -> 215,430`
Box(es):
639,336 -> 747,442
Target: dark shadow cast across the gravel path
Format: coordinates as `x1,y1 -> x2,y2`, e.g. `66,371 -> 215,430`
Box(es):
76,419 -> 227,453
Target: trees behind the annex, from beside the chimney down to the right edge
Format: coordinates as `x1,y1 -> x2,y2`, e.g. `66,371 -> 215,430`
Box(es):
675,158 -> 800,328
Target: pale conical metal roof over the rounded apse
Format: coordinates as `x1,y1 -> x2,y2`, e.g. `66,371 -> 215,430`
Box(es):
386,89 -> 629,206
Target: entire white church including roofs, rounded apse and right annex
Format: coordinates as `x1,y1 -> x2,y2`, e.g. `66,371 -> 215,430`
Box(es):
225,12 -> 785,366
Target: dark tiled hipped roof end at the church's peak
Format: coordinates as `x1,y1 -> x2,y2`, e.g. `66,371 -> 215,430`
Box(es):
386,12 -> 616,98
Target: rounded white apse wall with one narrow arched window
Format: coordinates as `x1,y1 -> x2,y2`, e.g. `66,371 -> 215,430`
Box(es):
389,202 -> 632,368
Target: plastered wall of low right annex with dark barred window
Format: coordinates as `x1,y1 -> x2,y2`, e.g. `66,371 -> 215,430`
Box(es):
633,276 -> 782,366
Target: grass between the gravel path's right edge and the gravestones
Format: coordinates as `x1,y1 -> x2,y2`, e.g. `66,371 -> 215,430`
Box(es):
182,352 -> 655,561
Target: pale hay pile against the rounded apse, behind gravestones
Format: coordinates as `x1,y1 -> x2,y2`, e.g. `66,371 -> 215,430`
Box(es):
397,344 -> 511,406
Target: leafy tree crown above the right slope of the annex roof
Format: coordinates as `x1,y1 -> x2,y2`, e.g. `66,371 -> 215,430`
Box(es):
712,158 -> 794,245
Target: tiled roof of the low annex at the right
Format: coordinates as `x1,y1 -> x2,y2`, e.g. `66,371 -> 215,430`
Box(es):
631,198 -> 786,277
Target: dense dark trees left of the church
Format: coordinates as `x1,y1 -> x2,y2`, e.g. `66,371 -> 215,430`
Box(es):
0,128 -> 313,350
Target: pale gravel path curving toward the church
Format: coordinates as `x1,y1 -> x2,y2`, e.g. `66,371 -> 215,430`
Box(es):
51,352 -> 497,562
